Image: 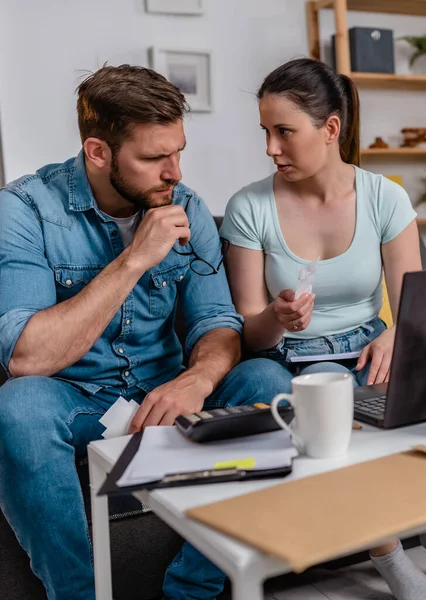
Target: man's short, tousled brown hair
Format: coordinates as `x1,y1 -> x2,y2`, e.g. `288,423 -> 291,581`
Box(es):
77,65 -> 189,151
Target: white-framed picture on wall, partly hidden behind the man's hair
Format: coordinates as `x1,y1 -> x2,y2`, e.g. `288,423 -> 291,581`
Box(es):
149,46 -> 213,112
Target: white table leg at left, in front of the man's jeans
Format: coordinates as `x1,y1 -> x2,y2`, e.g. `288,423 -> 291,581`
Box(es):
88,445 -> 113,600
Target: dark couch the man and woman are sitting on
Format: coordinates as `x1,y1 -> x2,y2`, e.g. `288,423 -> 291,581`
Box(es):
0,217 -> 426,600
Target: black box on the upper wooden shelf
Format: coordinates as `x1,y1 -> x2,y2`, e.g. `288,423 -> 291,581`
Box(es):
332,27 -> 395,73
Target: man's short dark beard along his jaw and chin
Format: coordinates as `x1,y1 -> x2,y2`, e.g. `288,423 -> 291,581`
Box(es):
109,154 -> 179,210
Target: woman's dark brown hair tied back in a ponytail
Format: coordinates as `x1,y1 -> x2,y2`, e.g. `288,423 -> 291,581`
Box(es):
257,58 -> 360,166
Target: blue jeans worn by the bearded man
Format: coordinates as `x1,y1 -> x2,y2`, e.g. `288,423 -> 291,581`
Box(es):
0,358 -> 286,600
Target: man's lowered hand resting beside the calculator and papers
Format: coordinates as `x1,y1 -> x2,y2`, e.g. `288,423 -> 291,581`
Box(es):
129,369 -> 213,433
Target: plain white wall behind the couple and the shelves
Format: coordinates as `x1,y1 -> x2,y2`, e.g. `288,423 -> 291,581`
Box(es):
0,0 -> 426,213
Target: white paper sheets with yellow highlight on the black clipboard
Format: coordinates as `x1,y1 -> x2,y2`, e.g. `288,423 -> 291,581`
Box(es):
117,427 -> 297,487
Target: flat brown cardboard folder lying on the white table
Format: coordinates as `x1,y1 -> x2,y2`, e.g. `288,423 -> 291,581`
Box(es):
186,446 -> 426,573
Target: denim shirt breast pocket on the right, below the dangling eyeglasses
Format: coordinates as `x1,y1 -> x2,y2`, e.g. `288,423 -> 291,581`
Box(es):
149,265 -> 188,317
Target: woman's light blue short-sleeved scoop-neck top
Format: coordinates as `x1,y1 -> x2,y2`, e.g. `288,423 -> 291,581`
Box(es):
220,167 -> 416,339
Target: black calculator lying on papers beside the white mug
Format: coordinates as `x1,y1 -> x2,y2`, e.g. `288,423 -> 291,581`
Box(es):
175,403 -> 294,442
